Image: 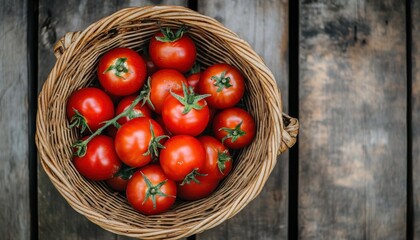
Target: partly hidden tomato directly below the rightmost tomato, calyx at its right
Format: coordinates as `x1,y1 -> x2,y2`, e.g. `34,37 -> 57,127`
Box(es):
198,136 -> 232,181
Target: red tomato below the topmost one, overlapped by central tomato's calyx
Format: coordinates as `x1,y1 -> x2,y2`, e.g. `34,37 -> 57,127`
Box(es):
150,69 -> 187,114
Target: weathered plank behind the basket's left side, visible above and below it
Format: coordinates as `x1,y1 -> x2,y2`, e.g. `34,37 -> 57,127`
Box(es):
38,0 -> 187,240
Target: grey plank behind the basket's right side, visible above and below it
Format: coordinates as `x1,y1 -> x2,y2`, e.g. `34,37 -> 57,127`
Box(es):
197,0 -> 288,239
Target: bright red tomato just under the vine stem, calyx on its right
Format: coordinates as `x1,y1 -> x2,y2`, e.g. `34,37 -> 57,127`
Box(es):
115,118 -> 166,167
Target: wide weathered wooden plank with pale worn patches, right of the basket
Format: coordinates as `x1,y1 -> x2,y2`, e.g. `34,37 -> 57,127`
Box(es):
298,0 -> 407,240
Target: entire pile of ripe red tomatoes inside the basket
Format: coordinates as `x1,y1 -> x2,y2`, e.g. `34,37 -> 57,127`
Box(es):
66,28 -> 255,215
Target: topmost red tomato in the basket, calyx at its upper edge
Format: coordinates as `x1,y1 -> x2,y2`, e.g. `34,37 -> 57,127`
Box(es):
149,28 -> 197,73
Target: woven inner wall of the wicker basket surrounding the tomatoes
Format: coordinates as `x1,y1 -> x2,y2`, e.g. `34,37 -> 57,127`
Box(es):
47,15 -> 277,236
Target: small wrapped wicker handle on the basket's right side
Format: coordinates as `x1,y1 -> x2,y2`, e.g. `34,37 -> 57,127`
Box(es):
278,113 -> 299,154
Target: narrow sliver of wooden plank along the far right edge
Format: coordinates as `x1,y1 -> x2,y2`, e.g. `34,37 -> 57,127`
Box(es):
411,0 -> 420,239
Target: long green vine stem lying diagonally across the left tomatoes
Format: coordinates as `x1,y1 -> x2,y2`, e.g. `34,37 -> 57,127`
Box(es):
72,93 -> 144,157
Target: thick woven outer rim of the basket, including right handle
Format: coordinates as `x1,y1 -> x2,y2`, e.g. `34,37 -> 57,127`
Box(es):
36,6 -> 299,238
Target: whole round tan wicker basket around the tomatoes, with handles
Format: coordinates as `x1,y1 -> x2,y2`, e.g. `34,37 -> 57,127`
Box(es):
36,6 -> 299,239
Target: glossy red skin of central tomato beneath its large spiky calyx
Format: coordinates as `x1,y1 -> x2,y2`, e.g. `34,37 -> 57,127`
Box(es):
162,93 -> 210,136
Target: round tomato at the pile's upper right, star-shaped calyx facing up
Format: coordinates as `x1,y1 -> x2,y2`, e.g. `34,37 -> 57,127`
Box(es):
197,63 -> 245,109
